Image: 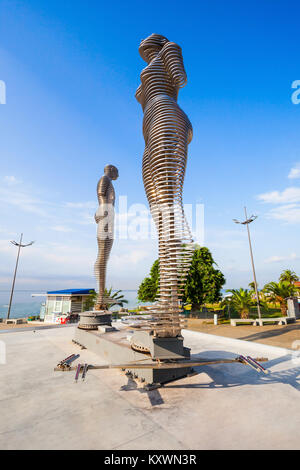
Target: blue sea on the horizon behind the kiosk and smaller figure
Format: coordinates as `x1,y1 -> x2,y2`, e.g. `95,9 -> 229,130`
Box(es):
0,290 -> 144,318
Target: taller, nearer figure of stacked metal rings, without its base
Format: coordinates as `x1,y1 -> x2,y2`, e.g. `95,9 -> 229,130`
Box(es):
136,34 -> 193,337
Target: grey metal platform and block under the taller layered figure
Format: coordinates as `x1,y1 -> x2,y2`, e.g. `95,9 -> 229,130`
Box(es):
74,327 -> 191,385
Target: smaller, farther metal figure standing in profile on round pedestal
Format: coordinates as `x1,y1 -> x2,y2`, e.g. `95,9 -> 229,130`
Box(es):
94,165 -> 119,310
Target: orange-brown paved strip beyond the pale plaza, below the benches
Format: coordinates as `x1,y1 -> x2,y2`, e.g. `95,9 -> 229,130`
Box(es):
187,318 -> 300,349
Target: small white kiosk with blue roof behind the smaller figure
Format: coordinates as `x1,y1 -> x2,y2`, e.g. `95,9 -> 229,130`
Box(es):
44,289 -> 95,323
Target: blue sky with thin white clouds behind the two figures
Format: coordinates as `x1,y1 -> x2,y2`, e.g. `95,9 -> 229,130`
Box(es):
0,0 -> 300,290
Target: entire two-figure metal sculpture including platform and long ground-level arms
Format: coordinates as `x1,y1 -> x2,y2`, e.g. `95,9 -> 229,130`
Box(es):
72,34 -> 267,390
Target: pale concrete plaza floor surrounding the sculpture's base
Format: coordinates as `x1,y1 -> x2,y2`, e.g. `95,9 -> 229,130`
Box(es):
0,327 -> 300,450
